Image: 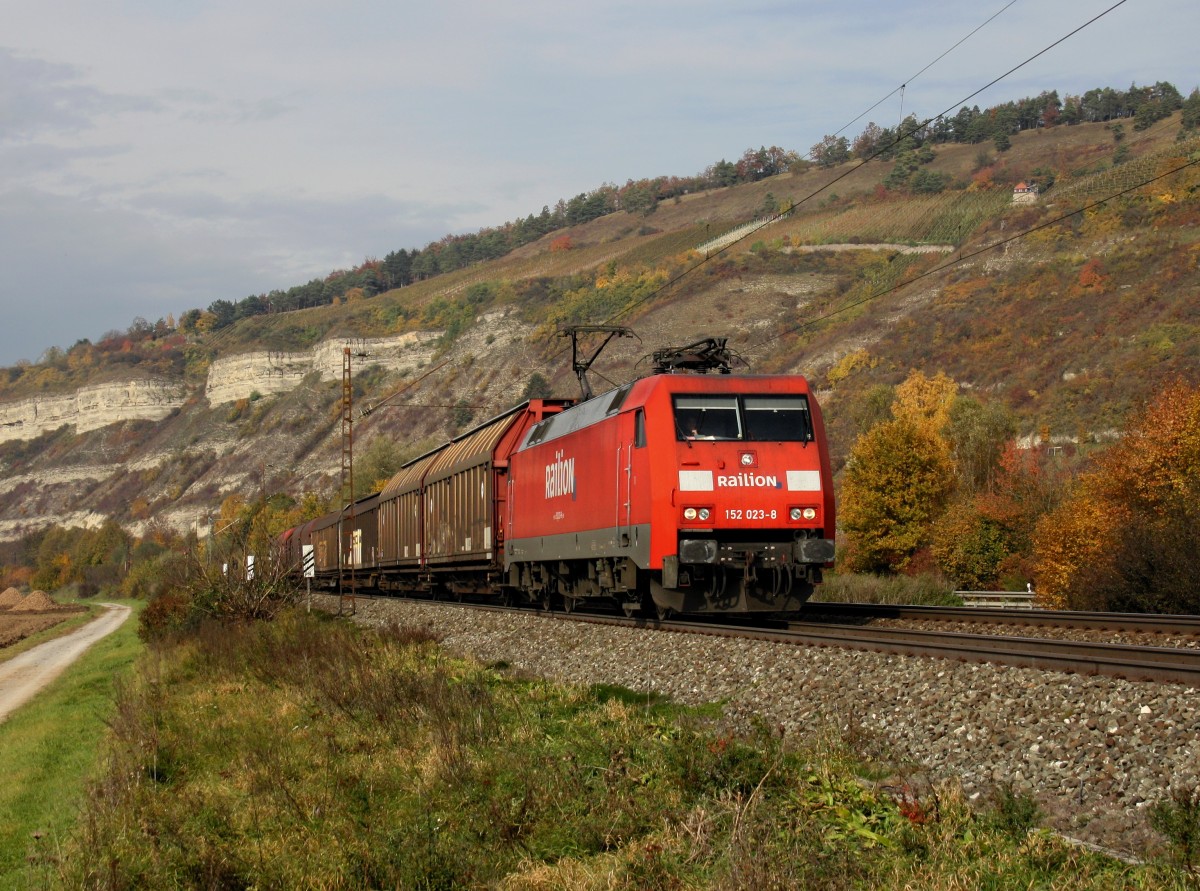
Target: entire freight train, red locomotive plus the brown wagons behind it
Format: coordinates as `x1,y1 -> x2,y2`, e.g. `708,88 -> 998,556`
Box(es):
281,329 -> 835,616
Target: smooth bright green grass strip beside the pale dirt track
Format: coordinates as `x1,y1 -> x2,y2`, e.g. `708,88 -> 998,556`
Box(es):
0,602 -> 143,889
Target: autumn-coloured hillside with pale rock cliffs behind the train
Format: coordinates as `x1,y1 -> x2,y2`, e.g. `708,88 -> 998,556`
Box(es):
0,114 -> 1200,540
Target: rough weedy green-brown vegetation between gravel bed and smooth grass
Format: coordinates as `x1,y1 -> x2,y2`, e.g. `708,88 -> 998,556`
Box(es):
22,609 -> 1188,889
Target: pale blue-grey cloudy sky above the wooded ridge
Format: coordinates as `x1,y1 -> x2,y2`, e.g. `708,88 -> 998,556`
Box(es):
0,0 -> 1200,366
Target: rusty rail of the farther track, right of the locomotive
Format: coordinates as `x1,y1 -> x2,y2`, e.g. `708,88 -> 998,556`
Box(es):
800,600 -> 1200,635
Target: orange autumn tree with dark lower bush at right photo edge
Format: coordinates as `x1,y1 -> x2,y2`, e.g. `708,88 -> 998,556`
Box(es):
1037,382 -> 1200,612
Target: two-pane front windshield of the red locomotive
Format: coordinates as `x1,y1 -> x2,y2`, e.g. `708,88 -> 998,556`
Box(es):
674,395 -> 812,442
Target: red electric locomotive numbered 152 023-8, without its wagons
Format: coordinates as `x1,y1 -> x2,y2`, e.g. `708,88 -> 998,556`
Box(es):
504,345 -> 835,615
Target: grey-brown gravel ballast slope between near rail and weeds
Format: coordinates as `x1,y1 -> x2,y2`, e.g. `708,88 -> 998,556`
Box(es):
322,598 -> 1200,856
